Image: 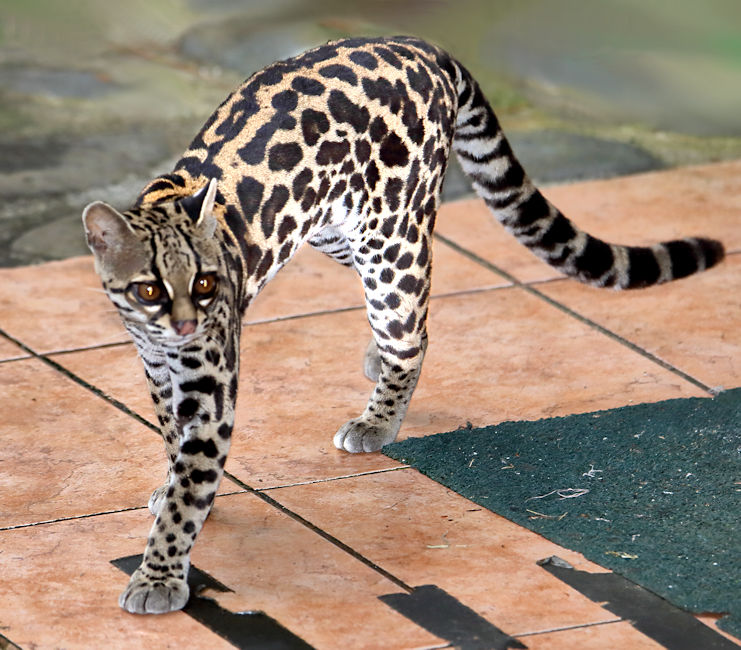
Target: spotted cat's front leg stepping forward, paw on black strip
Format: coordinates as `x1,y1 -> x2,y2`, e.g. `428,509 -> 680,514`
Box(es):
119,334 -> 238,614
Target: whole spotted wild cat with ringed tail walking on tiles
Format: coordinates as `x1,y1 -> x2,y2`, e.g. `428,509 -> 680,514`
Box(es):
83,37 -> 723,613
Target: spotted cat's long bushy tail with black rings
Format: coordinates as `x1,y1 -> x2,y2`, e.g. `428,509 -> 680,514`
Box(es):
446,63 -> 724,289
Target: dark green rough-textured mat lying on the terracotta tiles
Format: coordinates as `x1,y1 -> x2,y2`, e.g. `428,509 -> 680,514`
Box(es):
384,388 -> 741,638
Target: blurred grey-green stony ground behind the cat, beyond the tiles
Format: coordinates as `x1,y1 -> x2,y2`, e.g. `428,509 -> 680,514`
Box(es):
0,0 -> 741,265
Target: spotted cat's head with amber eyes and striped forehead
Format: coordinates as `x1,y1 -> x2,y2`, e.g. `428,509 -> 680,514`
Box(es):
82,179 -> 225,345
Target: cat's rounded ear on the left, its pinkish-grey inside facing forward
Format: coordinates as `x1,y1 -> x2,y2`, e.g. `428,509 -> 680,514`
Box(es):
82,201 -> 141,267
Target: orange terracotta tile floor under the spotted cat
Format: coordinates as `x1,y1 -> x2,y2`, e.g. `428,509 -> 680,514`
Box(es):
0,161 -> 741,649
